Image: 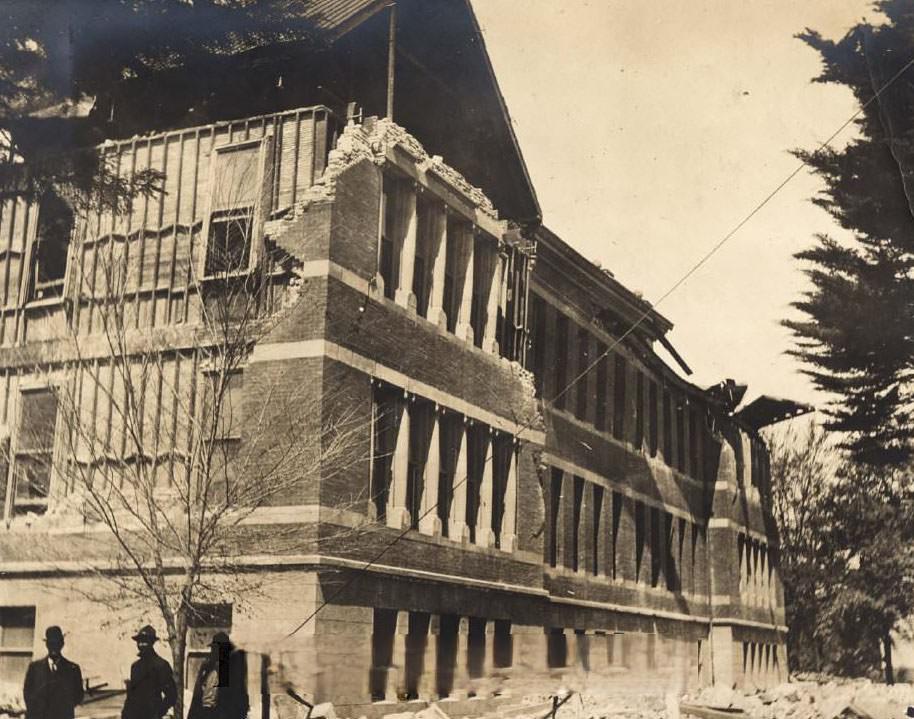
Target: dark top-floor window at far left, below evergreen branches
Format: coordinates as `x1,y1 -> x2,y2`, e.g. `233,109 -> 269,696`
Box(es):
29,190 -> 74,300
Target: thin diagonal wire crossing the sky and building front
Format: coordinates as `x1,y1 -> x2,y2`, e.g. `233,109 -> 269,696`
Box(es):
286,49 -> 914,639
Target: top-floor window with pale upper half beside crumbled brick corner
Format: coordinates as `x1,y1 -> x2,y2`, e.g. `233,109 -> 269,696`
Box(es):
204,140 -> 270,278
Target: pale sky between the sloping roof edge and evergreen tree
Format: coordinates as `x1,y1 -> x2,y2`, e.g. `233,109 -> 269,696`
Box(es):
472,0 -> 879,406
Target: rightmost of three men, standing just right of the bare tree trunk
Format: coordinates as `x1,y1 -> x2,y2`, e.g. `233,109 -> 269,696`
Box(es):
187,632 -> 250,719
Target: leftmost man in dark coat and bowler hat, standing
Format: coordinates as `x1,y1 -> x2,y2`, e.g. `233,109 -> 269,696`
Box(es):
22,627 -> 83,719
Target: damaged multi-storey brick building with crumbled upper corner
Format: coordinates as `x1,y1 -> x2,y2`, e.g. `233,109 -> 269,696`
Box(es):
0,0 -> 795,704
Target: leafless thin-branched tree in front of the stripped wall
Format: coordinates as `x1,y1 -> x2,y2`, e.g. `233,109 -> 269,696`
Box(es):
12,149 -> 370,717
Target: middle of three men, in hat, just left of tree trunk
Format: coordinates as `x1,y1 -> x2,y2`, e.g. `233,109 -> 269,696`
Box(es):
121,624 -> 178,719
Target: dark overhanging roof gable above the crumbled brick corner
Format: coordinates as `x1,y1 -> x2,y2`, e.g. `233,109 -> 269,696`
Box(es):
82,0 -> 541,225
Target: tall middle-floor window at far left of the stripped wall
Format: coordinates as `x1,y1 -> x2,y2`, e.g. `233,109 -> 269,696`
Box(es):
13,388 -> 57,514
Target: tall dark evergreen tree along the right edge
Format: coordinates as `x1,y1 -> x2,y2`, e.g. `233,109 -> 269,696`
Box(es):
784,0 -> 914,467
